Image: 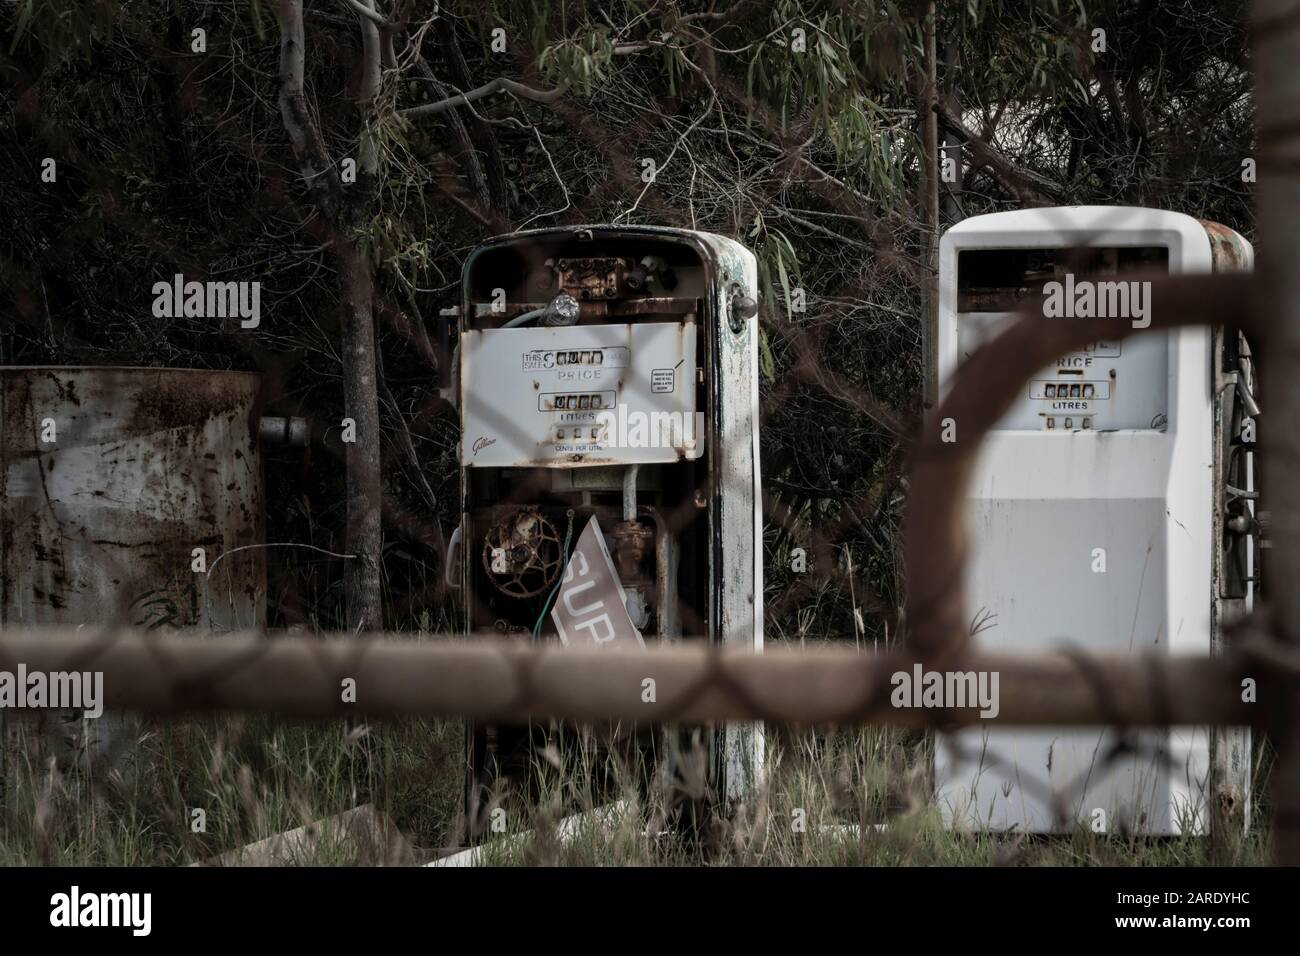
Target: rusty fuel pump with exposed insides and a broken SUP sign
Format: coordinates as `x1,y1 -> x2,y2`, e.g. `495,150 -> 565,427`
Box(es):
439,226 -> 763,831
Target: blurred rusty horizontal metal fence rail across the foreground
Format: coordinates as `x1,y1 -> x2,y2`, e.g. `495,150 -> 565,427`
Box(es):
0,630 -> 1281,727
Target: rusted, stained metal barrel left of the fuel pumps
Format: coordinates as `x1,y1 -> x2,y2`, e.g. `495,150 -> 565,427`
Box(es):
0,367 -> 267,770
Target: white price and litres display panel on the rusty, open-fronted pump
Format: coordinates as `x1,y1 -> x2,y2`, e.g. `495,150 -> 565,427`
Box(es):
460,321 -> 703,468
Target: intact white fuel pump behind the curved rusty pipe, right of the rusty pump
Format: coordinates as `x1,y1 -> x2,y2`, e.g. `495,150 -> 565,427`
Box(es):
935,207 -> 1257,834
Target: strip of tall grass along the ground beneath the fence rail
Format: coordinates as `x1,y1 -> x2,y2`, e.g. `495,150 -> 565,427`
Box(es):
0,717 -> 1269,866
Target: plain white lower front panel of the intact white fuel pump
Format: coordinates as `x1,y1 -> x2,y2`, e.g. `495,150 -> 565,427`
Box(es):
936,452 -> 1190,832
